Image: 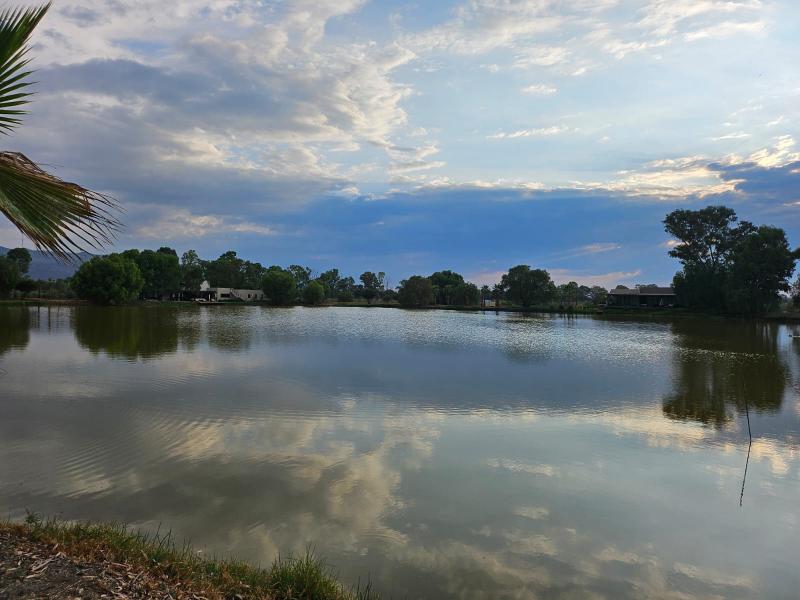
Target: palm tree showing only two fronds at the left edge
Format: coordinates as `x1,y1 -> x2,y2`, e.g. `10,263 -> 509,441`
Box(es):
0,3 -> 119,259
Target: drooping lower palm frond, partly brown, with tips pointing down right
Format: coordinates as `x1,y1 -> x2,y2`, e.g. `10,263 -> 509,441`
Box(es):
0,152 -> 120,260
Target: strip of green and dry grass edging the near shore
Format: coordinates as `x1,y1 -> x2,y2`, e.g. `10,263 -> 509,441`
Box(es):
0,517 -> 379,600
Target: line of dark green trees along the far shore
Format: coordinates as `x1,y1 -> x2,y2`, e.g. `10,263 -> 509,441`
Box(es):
0,206 -> 800,316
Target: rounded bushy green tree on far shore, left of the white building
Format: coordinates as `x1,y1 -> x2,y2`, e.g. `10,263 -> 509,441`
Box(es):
72,254 -> 144,304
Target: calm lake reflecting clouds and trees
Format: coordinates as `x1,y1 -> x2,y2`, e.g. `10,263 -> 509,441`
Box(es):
0,306 -> 800,599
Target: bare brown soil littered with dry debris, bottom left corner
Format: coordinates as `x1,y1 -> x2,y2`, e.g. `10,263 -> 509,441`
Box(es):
0,530 -> 205,600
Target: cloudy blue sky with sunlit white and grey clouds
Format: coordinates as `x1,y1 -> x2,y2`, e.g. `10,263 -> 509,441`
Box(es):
0,0 -> 800,286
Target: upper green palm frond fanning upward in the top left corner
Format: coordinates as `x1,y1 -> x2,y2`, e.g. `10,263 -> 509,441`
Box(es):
0,2 -> 50,133
